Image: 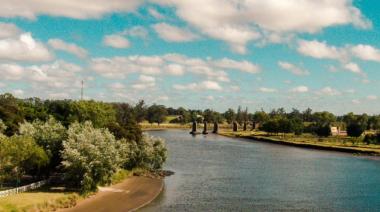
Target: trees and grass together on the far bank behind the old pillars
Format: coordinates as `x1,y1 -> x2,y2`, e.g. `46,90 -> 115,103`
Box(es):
140,104 -> 380,155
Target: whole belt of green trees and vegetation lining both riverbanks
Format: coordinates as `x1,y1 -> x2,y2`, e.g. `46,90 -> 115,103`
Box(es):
0,94 -> 380,210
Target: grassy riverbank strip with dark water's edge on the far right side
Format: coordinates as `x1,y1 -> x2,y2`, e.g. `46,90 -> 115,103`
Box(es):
218,131 -> 380,156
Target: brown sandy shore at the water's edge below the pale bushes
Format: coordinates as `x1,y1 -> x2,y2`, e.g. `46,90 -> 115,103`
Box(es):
60,177 -> 164,212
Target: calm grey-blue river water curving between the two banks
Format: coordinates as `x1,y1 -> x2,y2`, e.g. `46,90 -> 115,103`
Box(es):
142,130 -> 380,211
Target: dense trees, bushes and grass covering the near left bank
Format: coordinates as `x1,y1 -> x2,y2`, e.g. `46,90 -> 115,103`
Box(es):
0,94 -> 167,211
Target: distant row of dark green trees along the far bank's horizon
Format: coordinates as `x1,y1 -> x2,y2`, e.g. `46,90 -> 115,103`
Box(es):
123,101 -> 380,143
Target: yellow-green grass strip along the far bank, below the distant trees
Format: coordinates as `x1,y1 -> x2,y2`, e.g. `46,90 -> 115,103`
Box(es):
219,130 -> 380,155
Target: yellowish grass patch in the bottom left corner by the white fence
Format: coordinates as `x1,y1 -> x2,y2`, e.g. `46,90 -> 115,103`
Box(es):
0,187 -> 80,212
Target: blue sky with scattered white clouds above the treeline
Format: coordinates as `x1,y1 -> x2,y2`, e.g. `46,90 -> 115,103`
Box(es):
0,0 -> 380,114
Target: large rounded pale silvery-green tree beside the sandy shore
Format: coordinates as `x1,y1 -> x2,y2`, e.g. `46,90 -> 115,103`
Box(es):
62,122 -> 127,193
